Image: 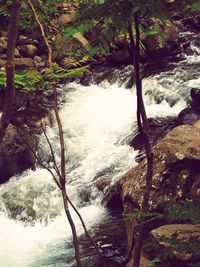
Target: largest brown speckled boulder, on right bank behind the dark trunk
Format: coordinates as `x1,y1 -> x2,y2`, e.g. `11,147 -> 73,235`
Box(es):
120,125 -> 200,208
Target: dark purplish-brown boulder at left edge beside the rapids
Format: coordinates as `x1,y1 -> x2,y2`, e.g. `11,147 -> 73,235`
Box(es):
0,124 -> 35,183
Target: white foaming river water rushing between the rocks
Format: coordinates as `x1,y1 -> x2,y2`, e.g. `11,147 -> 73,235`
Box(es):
0,33 -> 200,267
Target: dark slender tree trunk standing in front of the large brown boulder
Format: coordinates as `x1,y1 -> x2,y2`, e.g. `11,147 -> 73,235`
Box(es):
129,12 -> 153,267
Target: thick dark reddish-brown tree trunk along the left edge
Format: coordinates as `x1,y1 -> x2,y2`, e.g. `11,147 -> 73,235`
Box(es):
0,0 -> 21,143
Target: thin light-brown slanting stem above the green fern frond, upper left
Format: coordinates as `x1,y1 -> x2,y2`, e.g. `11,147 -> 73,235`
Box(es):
28,0 -> 52,68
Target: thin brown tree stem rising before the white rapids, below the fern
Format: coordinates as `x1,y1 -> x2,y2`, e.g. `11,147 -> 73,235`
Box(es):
54,89 -> 82,267
